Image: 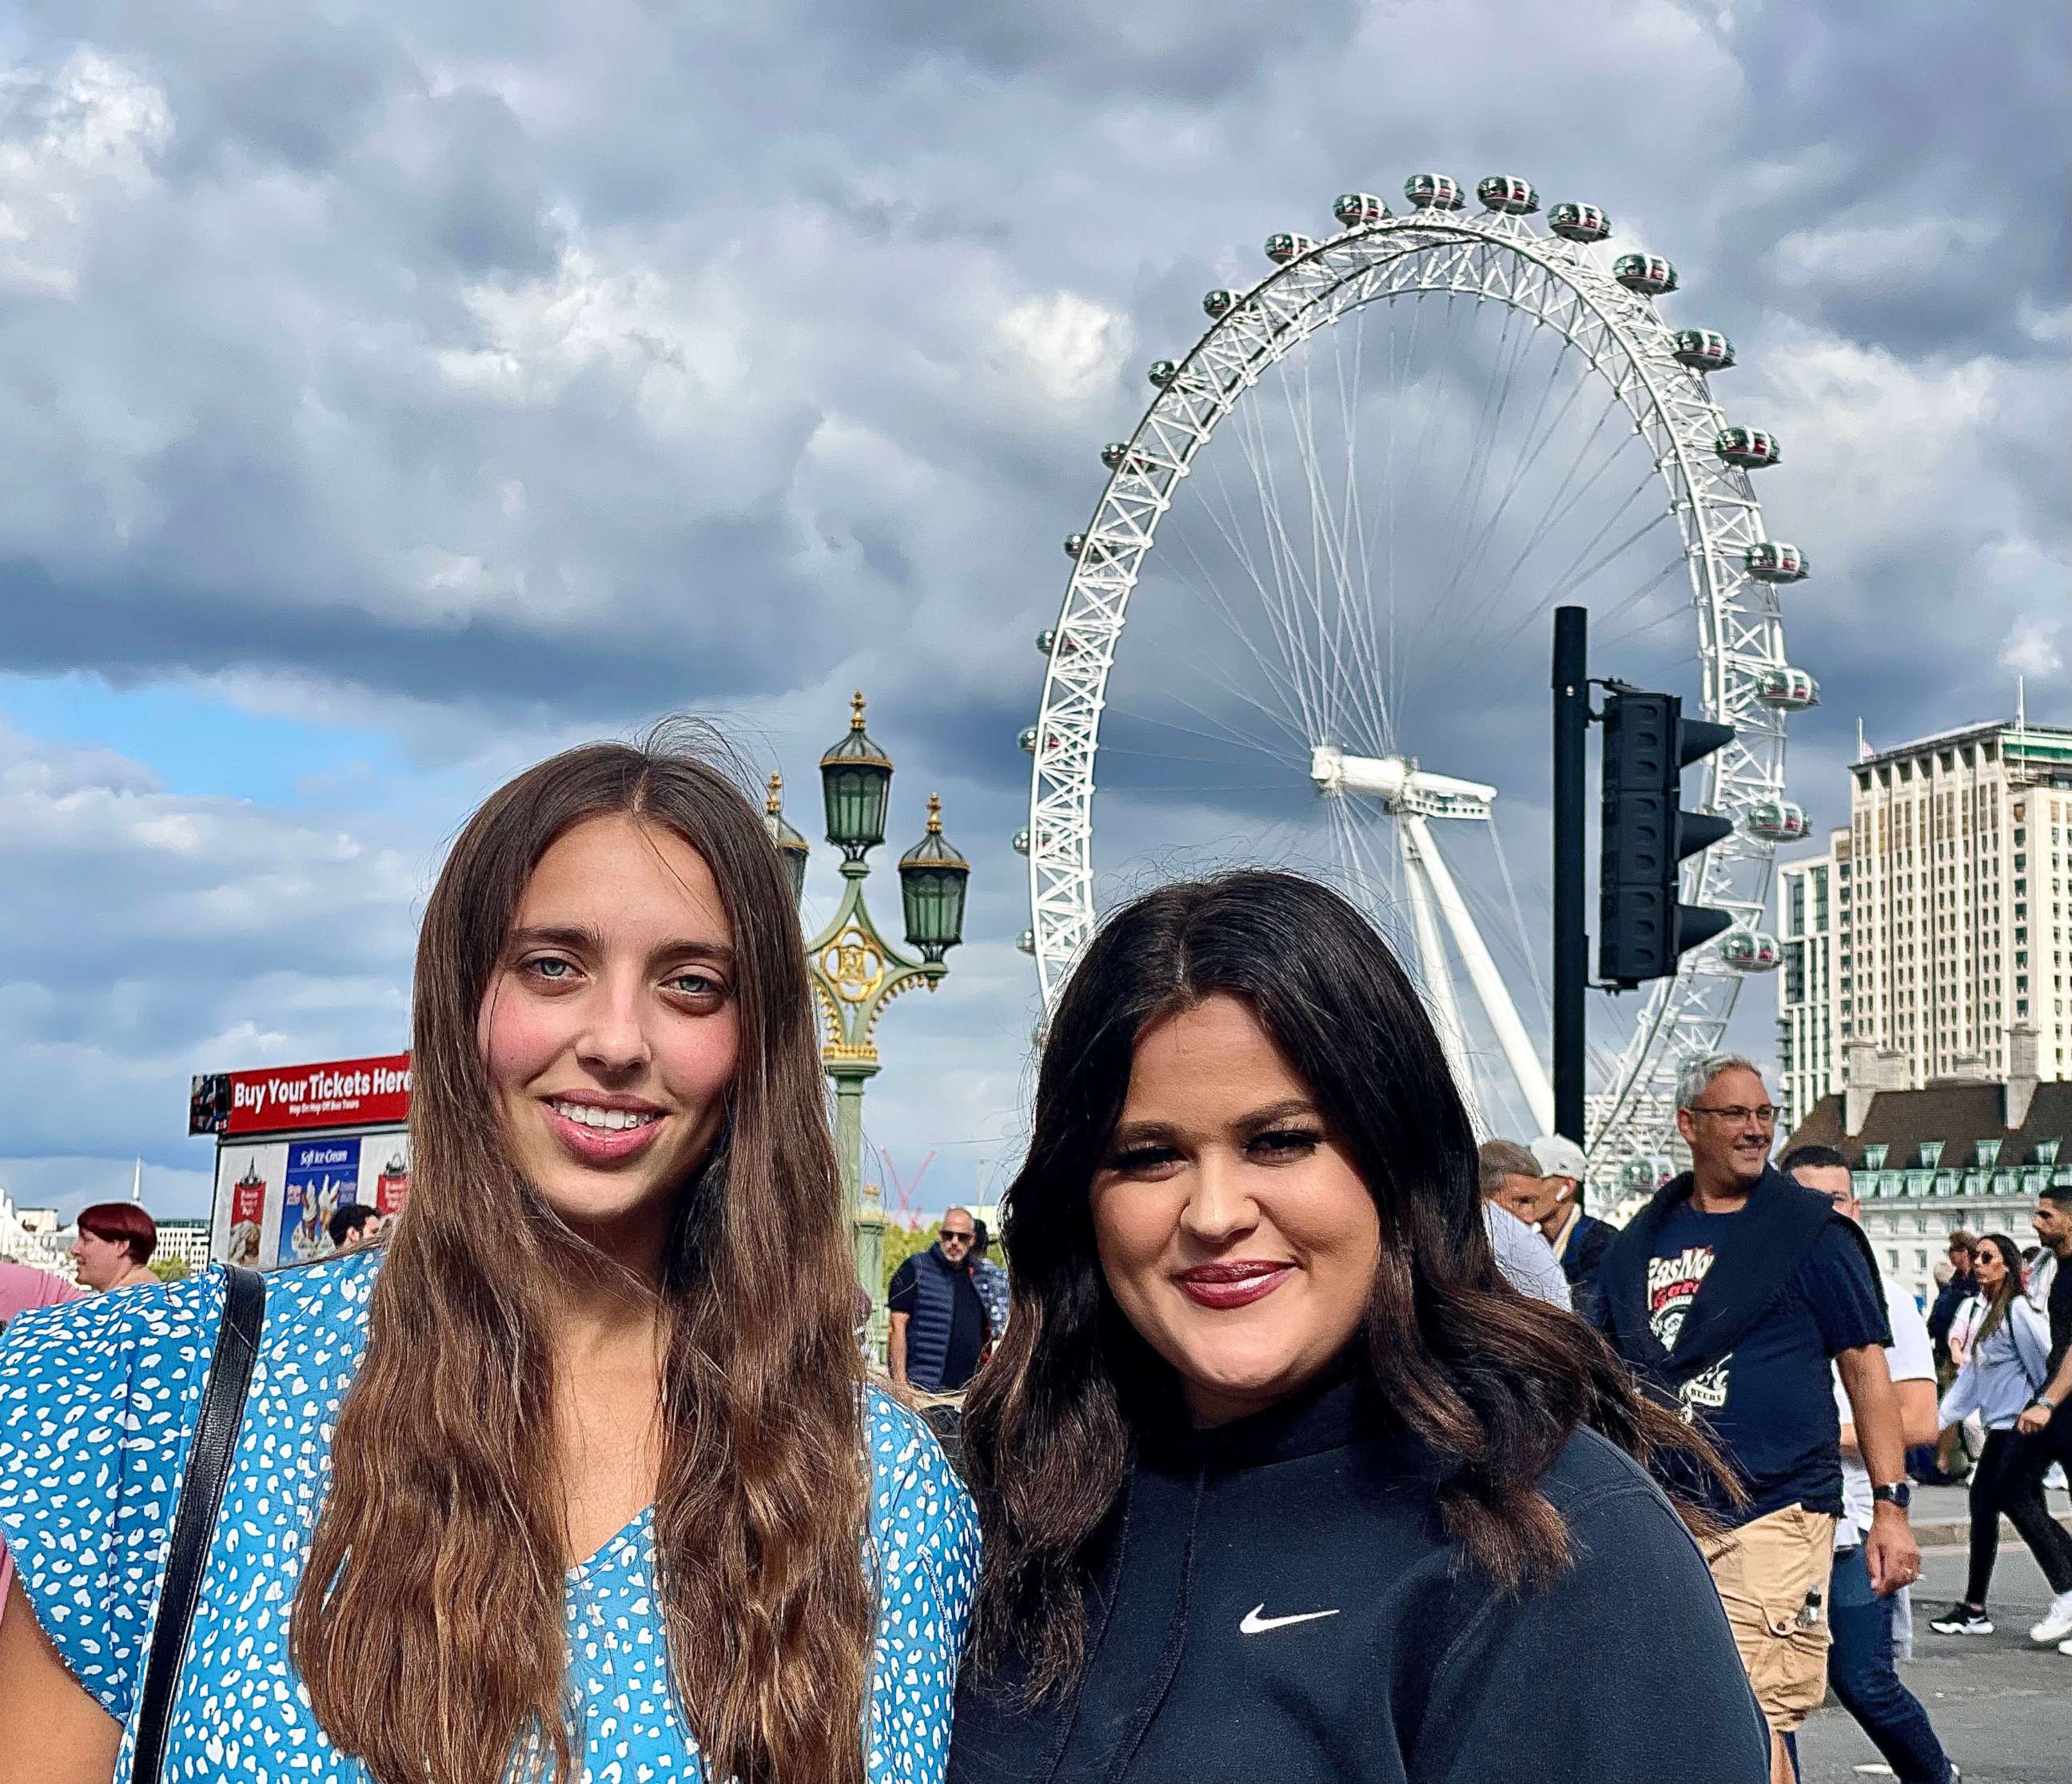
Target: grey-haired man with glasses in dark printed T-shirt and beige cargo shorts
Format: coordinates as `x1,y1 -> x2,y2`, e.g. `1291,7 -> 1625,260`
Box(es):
1593,1053 -> 1921,1784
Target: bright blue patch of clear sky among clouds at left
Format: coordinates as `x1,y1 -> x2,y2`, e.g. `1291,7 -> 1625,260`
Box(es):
0,675 -> 402,806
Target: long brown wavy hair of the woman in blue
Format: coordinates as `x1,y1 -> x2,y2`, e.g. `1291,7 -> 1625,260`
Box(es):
292,725 -> 876,1784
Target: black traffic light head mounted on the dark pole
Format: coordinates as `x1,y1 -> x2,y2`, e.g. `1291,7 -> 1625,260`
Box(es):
1597,686 -> 1735,990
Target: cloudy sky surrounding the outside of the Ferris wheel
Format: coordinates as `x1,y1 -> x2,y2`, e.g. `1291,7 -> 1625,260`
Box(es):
0,0 -> 2072,1214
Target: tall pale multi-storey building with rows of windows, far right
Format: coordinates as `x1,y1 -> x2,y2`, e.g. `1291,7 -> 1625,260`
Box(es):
1778,721 -> 2072,1123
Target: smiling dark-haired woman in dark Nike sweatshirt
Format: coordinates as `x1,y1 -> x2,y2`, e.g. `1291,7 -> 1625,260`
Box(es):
949,872 -> 1770,1784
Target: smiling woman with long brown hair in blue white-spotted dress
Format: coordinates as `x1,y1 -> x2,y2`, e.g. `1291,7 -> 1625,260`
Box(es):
0,742 -> 976,1784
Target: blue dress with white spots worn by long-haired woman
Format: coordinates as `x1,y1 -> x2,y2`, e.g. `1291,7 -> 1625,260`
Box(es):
0,1252 -> 978,1784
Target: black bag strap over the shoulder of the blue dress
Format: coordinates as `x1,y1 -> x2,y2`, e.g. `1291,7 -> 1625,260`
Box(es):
130,1264 -> 265,1784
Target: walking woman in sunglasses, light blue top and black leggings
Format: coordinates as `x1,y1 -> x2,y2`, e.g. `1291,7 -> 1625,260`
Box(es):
1929,1232 -> 2072,1639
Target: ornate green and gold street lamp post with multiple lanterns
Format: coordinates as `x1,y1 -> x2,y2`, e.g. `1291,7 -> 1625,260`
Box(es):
764,694 -> 972,1344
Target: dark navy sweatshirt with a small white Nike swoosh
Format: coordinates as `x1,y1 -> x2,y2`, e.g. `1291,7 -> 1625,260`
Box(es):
949,1378 -> 1770,1784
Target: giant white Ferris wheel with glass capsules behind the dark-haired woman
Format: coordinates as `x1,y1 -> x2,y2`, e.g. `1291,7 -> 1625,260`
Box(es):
1015,174 -> 1819,1181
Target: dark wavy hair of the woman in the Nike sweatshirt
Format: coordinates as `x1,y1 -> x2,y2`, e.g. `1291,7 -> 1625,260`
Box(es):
963,872 -> 1719,1699
